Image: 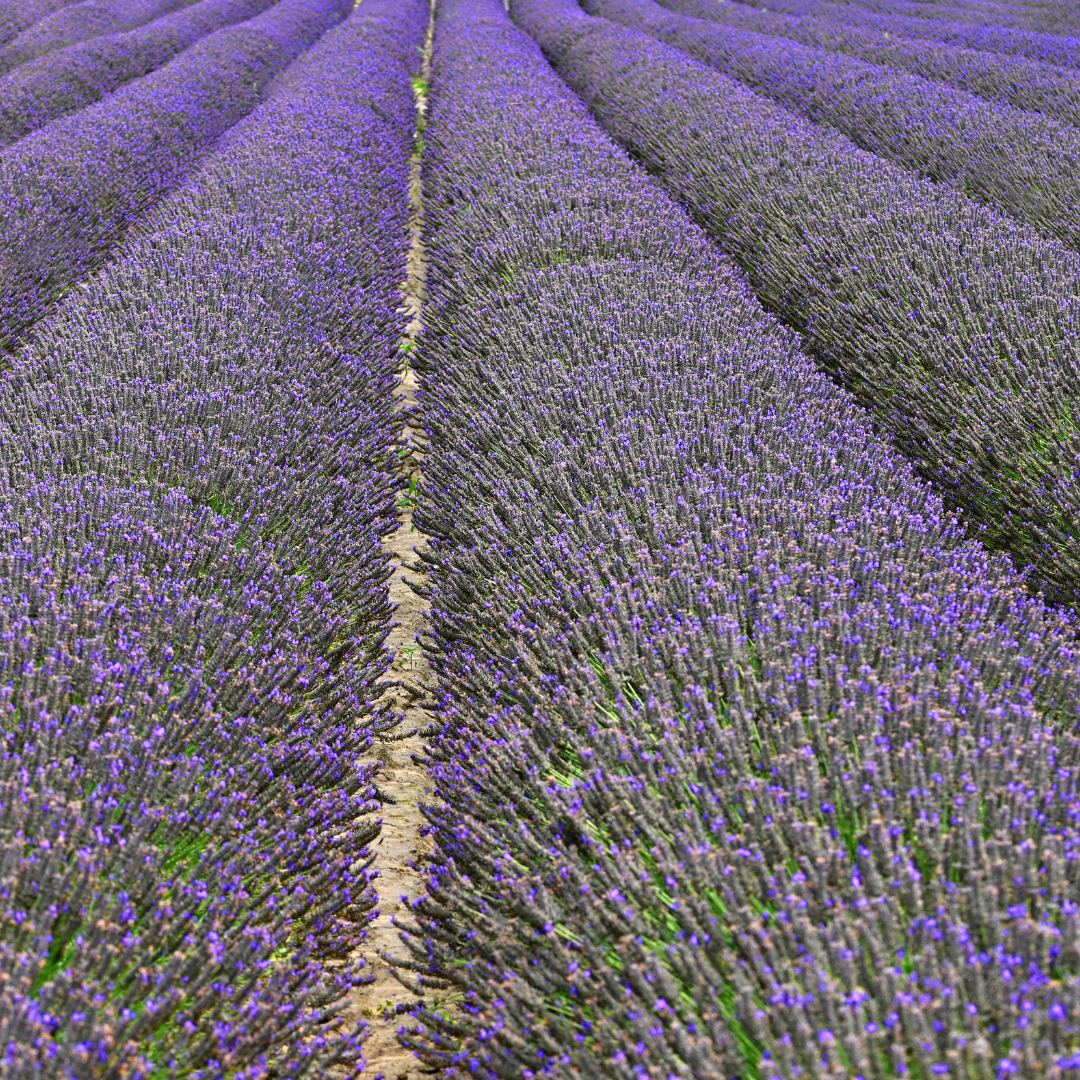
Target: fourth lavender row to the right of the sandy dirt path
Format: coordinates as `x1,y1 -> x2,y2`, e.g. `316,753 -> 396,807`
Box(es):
663,0 -> 1080,124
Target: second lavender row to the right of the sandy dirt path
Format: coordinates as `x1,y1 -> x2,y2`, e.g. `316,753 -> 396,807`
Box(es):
519,0 -> 1080,604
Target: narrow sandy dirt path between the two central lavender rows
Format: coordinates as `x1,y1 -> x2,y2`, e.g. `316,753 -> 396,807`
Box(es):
348,19 -> 434,1080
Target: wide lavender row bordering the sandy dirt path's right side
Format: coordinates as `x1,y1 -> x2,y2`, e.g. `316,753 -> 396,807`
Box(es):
403,0 -> 1080,1080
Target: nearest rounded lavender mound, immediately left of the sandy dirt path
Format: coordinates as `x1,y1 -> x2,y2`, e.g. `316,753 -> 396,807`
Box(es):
0,477 -> 377,1077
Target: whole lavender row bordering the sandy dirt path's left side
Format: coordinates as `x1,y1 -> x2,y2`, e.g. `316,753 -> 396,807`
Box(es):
0,0 -> 427,1067
